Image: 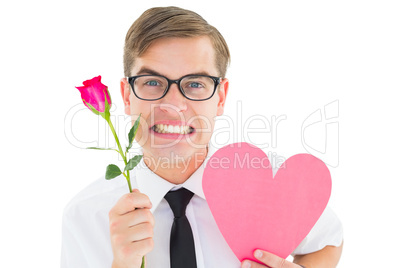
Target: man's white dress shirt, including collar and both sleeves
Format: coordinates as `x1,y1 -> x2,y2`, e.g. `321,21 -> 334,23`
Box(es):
61,147 -> 343,268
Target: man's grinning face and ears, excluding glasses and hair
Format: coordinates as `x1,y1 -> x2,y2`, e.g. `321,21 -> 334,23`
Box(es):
121,37 -> 228,163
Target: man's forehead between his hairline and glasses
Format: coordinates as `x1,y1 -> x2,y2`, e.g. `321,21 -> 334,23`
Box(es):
131,36 -> 218,79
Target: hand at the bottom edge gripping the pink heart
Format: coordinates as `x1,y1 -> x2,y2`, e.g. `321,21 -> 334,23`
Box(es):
241,249 -> 302,268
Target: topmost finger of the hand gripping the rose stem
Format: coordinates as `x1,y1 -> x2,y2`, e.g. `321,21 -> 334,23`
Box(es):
109,192 -> 152,216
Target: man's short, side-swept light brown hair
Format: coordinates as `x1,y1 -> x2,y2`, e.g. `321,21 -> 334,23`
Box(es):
123,6 -> 230,77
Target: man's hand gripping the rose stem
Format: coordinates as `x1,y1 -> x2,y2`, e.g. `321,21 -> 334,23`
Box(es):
109,189 -> 154,268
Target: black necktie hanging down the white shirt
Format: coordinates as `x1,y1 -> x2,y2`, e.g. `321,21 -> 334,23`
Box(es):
165,188 -> 197,268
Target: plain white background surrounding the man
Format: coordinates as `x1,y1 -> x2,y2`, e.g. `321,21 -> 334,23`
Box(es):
0,0 -> 402,267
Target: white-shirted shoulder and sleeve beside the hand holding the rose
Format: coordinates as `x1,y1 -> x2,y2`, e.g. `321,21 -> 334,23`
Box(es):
61,176 -> 133,267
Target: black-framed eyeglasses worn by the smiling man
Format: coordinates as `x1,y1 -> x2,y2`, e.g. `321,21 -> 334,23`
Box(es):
127,74 -> 222,101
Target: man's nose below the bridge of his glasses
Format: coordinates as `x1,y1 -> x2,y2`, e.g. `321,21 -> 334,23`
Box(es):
160,83 -> 187,113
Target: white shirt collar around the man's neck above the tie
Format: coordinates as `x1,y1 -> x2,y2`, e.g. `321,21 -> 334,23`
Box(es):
135,146 -> 216,213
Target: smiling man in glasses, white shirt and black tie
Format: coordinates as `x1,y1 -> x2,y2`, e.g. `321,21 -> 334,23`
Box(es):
62,7 -> 342,268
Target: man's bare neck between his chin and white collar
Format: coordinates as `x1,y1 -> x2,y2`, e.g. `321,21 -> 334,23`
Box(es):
144,148 -> 208,184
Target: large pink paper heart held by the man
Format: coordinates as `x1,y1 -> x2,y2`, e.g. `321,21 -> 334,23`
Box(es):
202,142 -> 331,261
